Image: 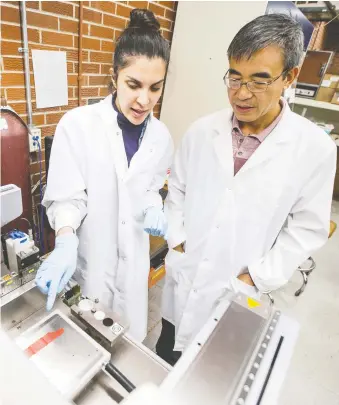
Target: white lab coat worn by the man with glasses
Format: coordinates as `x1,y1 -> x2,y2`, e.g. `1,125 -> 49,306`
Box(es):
162,102 -> 336,350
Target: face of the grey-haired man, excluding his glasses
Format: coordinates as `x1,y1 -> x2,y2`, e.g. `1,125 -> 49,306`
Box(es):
228,46 -> 294,122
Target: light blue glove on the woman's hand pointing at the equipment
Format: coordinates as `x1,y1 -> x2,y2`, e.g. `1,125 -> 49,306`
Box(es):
35,233 -> 79,311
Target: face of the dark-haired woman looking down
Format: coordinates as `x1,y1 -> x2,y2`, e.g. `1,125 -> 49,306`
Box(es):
116,56 -> 166,125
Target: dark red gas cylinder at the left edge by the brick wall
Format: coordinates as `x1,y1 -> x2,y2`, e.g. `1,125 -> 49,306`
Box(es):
1,107 -> 33,234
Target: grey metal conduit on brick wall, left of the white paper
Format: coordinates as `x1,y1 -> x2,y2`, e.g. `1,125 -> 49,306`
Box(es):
20,1 -> 33,129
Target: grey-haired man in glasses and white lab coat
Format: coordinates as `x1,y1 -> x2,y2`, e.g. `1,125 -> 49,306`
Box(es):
157,14 -> 336,364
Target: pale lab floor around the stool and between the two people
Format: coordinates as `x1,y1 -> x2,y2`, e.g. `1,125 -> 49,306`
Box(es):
145,202 -> 339,405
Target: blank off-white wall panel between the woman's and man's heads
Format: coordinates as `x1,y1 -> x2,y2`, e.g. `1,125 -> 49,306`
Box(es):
160,1 -> 267,145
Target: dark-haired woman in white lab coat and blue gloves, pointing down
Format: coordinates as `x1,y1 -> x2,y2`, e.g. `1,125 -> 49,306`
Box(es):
36,9 -> 173,341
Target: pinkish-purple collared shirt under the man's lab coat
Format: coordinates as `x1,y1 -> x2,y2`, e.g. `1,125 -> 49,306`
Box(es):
232,99 -> 286,175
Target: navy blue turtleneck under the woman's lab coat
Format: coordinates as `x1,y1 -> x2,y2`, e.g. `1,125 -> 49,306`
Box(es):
112,95 -> 145,167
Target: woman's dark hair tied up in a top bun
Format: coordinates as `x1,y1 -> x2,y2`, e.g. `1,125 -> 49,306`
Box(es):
113,8 -> 170,75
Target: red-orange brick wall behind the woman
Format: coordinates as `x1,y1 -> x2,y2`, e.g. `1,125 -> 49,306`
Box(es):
0,1 -> 177,218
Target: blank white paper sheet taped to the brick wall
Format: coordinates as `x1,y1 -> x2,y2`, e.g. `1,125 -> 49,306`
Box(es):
32,49 -> 68,108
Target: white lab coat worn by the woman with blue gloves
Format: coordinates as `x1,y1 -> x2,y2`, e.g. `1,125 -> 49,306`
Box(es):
43,96 -> 173,341
